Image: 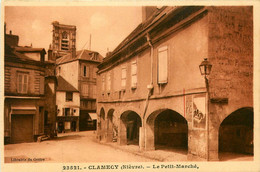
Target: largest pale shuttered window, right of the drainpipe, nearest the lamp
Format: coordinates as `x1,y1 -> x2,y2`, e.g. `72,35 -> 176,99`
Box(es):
158,46 -> 168,84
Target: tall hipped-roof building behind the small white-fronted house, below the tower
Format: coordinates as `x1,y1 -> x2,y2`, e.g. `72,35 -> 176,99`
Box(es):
56,50 -> 103,131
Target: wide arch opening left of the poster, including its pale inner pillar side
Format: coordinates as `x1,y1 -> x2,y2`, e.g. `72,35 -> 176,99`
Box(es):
146,109 -> 188,151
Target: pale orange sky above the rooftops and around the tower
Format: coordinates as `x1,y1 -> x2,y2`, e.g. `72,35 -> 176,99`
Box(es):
5,6 -> 142,57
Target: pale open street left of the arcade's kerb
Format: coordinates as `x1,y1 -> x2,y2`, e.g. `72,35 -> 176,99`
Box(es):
4,131 -> 156,163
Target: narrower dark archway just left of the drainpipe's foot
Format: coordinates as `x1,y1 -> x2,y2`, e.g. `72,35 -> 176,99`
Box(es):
120,111 -> 142,145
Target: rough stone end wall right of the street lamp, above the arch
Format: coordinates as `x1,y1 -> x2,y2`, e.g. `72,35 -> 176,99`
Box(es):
208,6 -> 253,159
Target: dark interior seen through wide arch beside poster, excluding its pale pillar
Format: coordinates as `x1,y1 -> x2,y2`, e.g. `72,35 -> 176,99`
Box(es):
154,109 -> 188,150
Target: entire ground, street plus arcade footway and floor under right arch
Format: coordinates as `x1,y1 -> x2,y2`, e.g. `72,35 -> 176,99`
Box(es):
4,131 -> 253,163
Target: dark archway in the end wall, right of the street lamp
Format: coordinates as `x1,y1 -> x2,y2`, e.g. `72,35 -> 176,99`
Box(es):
219,108 -> 254,159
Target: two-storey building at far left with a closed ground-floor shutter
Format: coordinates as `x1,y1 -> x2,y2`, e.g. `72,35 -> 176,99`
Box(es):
4,31 -> 45,143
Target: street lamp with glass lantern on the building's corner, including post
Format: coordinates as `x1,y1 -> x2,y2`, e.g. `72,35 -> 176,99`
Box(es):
199,58 -> 212,160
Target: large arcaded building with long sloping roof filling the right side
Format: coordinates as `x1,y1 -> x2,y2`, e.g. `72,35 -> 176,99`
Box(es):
97,6 -> 254,160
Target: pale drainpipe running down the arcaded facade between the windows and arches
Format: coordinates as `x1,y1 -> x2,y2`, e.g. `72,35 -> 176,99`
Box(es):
141,33 -> 153,149
